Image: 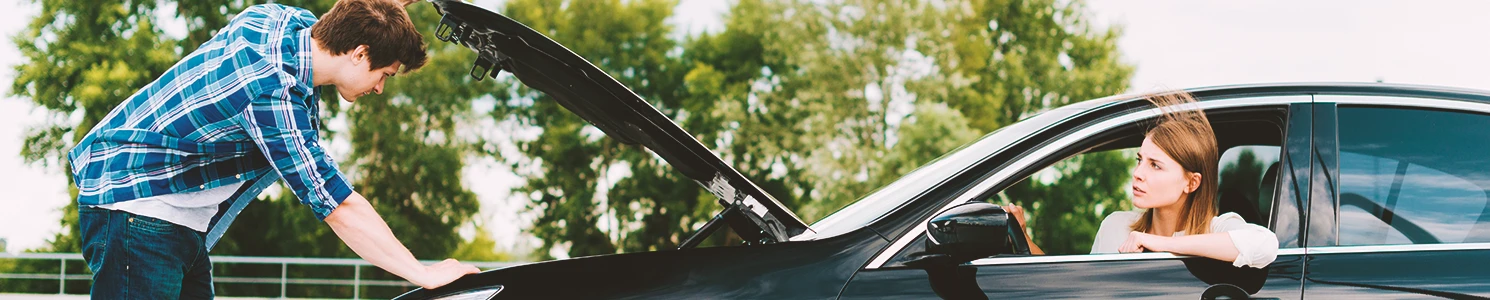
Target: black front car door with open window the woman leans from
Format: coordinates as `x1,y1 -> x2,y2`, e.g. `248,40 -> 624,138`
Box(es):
840,96 -> 1311,299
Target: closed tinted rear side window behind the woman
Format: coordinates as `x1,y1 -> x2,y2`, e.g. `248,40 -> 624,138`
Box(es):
1340,106 -> 1490,245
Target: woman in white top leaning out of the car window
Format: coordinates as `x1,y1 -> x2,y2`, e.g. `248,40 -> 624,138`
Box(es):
1009,93 -> 1278,269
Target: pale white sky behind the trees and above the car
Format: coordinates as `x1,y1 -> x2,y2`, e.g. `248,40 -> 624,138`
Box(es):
0,0 -> 1490,252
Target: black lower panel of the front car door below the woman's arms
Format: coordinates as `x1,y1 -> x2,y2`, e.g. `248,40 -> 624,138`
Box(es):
840,255 -> 1304,299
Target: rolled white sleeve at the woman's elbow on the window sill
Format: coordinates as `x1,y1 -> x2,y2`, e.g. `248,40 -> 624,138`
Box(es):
1211,212 -> 1278,269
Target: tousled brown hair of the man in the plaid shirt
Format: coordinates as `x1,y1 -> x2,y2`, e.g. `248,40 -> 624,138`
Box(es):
310,0 -> 426,73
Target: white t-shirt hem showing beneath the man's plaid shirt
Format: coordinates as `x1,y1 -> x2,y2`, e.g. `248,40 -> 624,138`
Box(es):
98,182 -> 243,233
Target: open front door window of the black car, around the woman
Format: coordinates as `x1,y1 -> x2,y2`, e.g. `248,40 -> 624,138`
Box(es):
983,116 -> 1292,255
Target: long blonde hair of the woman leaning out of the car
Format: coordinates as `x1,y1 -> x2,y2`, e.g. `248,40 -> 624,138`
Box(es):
1132,91 -> 1220,236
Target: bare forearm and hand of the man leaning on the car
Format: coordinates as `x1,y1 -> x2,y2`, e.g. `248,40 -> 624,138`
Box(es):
326,193 -> 481,288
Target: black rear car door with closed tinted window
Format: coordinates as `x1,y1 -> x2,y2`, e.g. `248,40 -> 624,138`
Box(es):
1304,96 -> 1490,299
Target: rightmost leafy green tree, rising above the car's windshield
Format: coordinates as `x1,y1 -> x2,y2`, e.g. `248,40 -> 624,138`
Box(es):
697,0 -> 1131,221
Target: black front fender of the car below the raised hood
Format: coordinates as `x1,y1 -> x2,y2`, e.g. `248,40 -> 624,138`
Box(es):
398,230 -> 885,299
